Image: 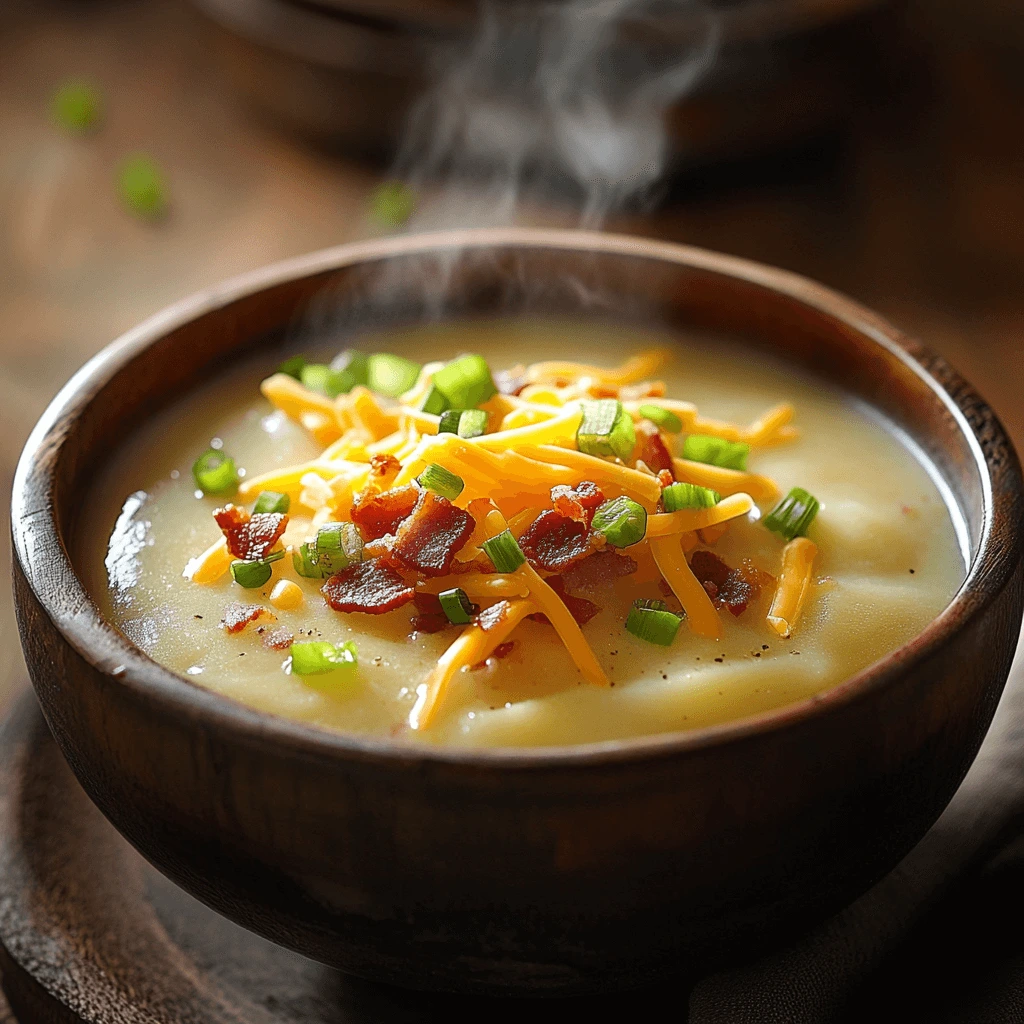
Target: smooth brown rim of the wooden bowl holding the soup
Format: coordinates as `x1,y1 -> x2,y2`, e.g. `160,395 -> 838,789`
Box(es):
11,228 -> 1018,770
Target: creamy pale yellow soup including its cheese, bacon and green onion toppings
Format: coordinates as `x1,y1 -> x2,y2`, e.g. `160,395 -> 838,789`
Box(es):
81,322 -> 965,746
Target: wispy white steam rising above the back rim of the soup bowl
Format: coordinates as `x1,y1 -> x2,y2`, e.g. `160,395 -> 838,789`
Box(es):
393,0 -> 719,229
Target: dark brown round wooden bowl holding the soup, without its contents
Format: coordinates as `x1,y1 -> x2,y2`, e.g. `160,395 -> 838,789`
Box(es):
12,229 -> 1024,994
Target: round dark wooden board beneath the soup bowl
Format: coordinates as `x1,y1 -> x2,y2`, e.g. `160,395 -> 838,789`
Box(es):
0,693 -> 685,1024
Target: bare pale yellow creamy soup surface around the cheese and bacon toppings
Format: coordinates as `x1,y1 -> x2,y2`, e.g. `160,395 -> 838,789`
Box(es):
80,321 -> 965,746
